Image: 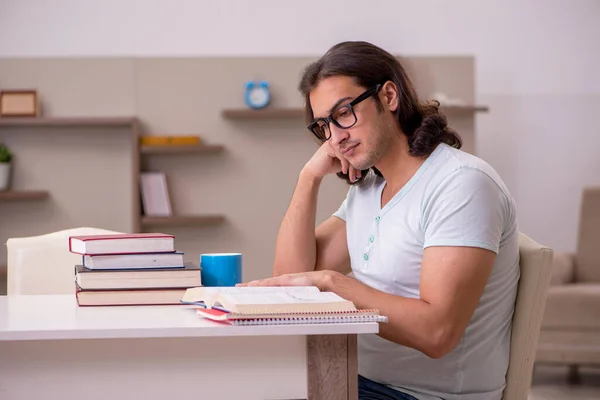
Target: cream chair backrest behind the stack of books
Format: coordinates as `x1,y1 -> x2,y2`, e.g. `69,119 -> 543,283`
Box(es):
6,227 -> 120,296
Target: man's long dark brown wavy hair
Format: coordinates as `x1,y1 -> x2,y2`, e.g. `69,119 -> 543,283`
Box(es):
298,42 -> 462,183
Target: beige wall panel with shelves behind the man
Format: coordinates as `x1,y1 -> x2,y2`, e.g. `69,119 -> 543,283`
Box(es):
0,56 -> 486,280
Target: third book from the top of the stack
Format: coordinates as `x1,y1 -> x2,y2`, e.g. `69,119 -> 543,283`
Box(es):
75,263 -> 202,290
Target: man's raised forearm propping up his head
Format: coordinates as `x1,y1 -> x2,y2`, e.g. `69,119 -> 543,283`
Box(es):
273,171 -> 322,276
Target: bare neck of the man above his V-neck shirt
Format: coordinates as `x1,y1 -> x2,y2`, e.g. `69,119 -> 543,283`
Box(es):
375,135 -> 426,193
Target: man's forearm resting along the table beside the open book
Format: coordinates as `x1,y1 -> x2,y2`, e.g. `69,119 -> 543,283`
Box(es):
321,272 -> 456,358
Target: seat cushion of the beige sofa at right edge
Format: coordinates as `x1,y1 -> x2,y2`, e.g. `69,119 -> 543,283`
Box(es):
542,283 -> 600,329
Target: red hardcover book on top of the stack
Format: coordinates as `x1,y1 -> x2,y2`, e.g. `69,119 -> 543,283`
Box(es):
69,233 -> 175,255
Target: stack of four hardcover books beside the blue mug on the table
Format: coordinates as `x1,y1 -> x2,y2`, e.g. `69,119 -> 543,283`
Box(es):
69,233 -> 202,306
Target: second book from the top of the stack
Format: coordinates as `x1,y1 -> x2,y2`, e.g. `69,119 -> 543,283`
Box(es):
82,251 -> 184,270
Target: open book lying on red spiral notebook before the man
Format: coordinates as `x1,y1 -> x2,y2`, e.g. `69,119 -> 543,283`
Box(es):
181,286 -> 387,325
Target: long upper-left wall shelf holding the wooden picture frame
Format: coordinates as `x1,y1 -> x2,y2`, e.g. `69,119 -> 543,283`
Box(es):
0,117 -> 137,127
